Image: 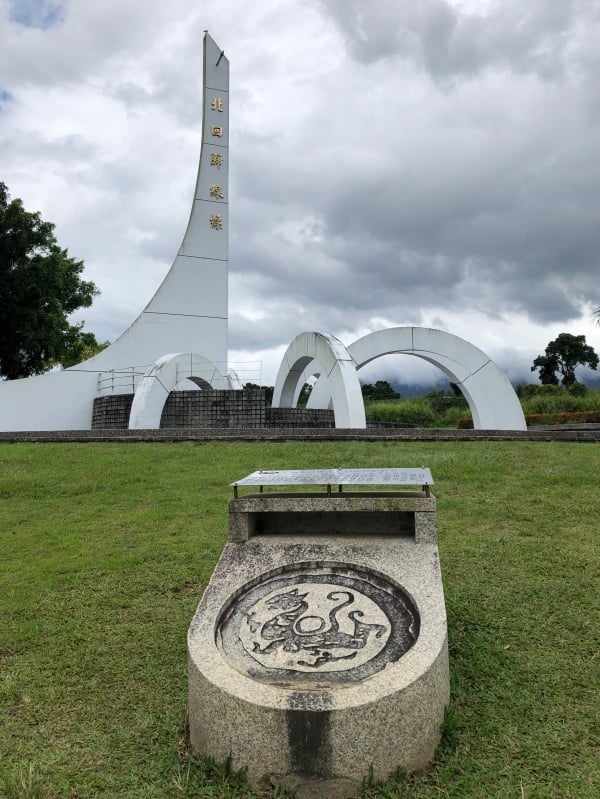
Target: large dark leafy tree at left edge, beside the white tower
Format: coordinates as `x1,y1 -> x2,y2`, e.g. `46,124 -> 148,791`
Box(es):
0,182 -> 103,379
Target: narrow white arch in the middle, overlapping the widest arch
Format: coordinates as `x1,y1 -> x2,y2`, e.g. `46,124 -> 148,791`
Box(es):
272,332 -> 367,428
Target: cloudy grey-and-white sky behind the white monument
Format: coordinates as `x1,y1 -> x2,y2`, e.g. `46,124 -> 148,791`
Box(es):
0,0 -> 600,383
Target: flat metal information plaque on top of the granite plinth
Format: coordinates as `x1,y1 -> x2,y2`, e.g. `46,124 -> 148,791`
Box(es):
231,467 -> 433,491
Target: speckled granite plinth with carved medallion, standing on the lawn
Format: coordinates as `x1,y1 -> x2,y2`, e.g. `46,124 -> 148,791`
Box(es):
188,470 -> 449,799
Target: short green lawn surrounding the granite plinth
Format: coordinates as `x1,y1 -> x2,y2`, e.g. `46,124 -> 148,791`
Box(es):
0,441 -> 600,799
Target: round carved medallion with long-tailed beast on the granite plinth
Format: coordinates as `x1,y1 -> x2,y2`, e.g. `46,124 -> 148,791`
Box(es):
217,564 -> 418,684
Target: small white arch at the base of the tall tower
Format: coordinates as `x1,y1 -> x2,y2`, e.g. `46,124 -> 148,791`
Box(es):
129,352 -> 229,430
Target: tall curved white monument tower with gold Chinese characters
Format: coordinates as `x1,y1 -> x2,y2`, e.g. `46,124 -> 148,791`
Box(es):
0,34 -> 229,431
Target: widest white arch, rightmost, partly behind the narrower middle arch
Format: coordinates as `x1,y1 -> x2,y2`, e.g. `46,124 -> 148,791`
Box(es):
308,327 -> 527,430
